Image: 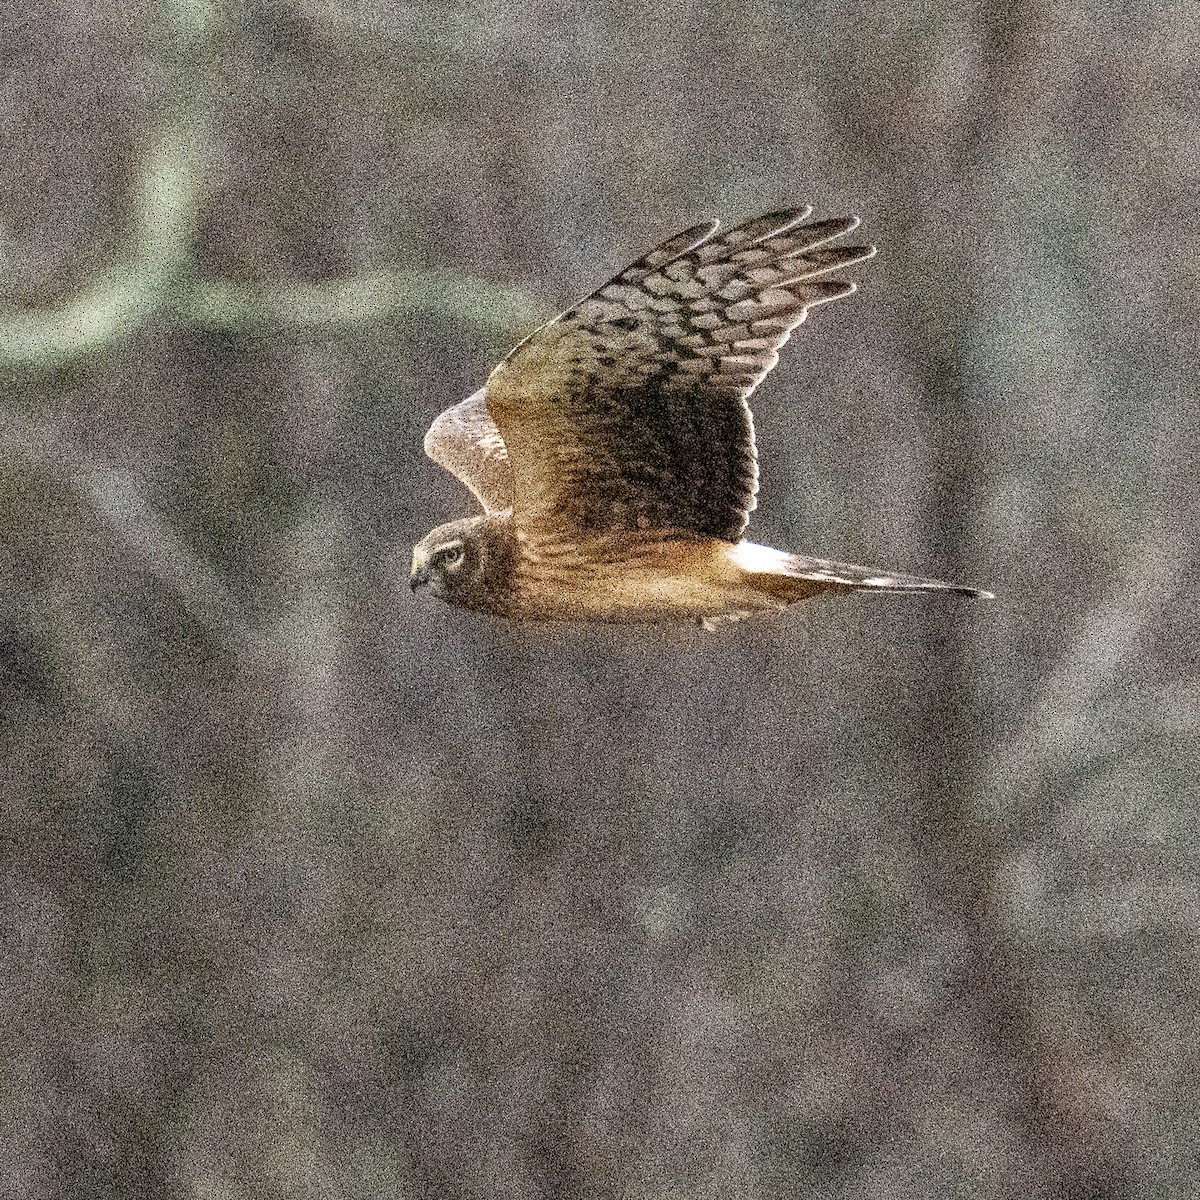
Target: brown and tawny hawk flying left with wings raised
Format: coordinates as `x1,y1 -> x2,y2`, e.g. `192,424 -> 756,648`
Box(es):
410,208 -> 989,628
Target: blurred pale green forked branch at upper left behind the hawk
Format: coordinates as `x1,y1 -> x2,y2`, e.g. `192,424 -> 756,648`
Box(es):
0,0 -> 540,372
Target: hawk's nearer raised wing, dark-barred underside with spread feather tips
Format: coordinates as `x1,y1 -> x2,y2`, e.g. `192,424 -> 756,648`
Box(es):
486,208 -> 875,541
